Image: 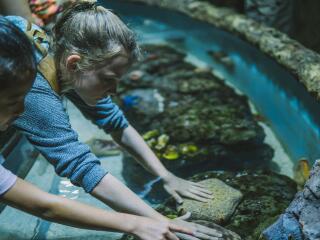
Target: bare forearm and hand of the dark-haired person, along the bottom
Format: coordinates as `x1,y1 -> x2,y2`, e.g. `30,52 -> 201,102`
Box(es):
0,178 -> 190,240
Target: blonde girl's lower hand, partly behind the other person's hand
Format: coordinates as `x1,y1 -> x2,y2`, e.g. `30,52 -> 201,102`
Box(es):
171,218 -> 223,240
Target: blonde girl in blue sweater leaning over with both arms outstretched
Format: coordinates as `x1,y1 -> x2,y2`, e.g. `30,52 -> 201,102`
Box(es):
8,1 -> 219,239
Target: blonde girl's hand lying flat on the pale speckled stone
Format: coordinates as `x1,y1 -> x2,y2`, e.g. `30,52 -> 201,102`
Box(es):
162,173 -> 213,204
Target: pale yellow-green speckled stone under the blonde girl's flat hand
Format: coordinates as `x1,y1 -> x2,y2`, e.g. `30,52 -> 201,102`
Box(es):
178,178 -> 242,224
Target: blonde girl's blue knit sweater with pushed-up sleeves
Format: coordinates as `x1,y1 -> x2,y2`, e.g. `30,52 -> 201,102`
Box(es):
7,16 -> 128,192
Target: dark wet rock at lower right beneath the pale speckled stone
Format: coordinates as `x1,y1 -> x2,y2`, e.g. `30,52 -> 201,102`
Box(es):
123,170 -> 297,240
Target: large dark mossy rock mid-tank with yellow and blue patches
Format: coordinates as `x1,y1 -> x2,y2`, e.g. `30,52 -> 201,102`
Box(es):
119,45 -> 273,174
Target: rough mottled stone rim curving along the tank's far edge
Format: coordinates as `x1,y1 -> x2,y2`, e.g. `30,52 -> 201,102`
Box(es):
127,0 -> 320,98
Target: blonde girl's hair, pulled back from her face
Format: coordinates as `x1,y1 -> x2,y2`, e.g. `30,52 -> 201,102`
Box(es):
53,1 -> 139,91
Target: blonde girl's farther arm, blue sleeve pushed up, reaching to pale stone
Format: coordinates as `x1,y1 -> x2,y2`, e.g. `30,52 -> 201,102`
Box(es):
67,91 -> 212,203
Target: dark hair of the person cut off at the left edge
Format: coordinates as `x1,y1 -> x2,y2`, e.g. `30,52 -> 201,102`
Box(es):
0,15 -> 37,91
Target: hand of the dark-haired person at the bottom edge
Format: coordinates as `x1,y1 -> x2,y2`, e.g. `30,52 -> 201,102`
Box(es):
131,217 -> 193,240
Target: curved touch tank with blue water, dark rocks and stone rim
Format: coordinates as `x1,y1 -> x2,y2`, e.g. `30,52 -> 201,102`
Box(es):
102,0 -> 320,239
